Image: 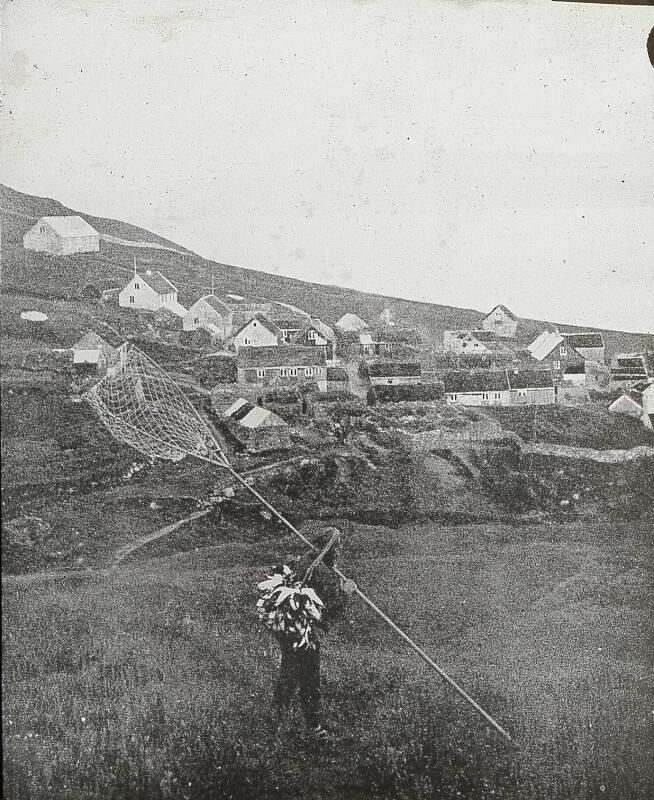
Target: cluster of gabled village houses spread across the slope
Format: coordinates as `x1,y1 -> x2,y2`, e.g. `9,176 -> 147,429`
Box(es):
16,215 -> 654,462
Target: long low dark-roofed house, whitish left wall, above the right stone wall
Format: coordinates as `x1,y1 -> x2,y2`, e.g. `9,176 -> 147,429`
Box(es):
442,369 -> 556,406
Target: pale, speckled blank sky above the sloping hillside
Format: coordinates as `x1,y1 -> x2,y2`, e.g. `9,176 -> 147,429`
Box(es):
0,0 -> 654,332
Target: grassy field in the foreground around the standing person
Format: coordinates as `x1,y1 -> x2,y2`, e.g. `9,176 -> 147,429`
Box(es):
3,522 -> 654,800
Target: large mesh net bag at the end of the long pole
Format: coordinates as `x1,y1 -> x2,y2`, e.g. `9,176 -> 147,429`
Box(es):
85,345 -> 227,464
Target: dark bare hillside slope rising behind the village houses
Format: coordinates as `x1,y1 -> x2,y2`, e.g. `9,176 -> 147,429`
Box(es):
0,185 -> 648,355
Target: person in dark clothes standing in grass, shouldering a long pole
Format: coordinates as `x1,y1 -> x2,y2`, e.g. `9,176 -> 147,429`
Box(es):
273,527 -> 357,742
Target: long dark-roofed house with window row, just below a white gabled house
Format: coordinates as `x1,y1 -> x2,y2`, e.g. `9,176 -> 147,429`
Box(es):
236,344 -> 327,392
